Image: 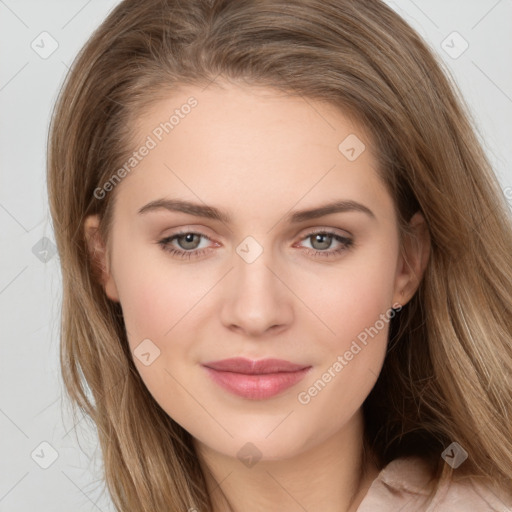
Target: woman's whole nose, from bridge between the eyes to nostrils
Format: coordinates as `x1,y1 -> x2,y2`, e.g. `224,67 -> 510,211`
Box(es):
222,237 -> 293,335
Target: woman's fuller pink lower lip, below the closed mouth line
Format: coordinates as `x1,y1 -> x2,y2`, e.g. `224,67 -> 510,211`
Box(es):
203,366 -> 311,400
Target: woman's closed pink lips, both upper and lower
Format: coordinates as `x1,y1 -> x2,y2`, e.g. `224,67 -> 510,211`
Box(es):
202,358 -> 312,400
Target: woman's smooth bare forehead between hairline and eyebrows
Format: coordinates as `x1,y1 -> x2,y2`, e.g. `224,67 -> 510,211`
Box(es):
112,83 -> 390,221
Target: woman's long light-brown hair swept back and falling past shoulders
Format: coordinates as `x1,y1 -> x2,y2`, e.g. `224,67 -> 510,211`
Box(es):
48,0 -> 512,512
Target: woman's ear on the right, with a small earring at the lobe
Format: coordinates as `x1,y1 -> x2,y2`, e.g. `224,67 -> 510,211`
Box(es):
393,212 -> 430,306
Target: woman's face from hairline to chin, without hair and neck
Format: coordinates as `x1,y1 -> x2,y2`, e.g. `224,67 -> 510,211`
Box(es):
86,84 -> 424,460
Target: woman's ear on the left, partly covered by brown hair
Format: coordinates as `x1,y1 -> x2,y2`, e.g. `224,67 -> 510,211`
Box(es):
84,215 -> 119,302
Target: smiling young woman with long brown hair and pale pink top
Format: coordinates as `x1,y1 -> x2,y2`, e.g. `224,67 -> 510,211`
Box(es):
48,0 -> 512,512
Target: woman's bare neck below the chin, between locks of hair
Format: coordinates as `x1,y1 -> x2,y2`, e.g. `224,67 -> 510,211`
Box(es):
195,411 -> 379,512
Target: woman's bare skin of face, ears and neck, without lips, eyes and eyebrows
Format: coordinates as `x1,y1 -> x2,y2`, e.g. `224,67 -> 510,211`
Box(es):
85,83 -> 429,512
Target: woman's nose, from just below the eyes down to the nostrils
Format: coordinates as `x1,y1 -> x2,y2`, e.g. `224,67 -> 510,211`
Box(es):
221,246 -> 293,337
